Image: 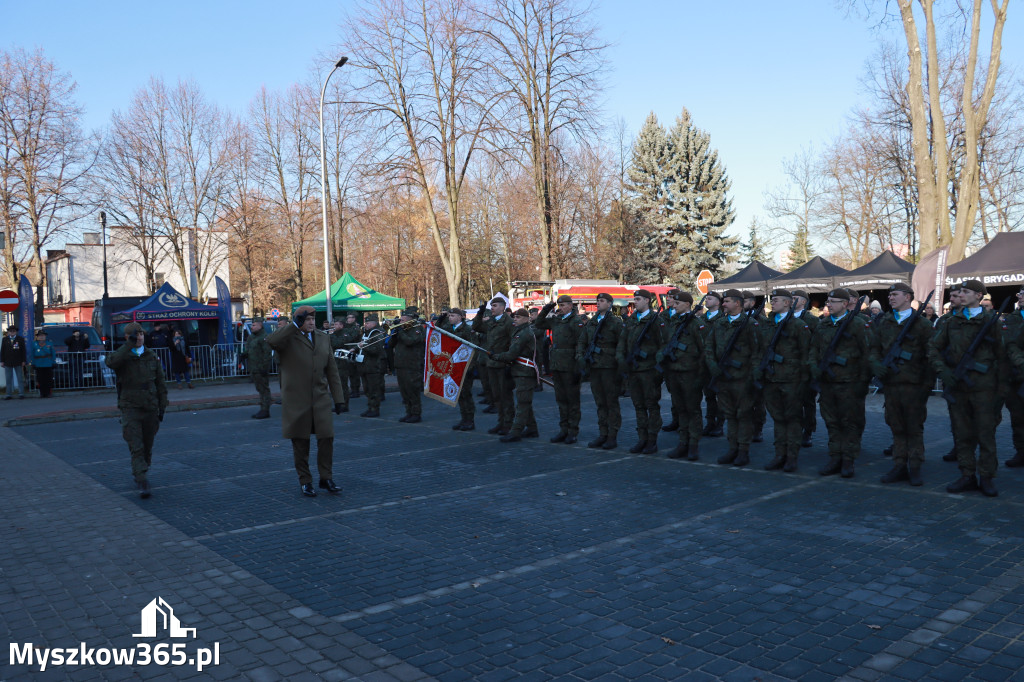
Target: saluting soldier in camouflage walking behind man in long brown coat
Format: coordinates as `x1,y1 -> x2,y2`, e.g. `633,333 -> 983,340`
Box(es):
105,323 -> 167,498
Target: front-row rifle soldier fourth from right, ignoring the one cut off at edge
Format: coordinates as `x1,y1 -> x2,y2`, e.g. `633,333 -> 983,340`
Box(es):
754,289 -> 811,473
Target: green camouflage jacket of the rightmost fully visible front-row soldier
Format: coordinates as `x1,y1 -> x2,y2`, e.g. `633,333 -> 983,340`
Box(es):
929,309 -> 1009,392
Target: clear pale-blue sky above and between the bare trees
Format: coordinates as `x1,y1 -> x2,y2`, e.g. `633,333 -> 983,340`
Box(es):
0,0 -> 1024,249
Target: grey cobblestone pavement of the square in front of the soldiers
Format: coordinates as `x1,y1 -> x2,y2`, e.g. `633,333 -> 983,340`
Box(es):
6,387 -> 1024,681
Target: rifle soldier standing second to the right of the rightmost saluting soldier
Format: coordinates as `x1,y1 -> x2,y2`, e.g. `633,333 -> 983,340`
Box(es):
615,289 -> 662,455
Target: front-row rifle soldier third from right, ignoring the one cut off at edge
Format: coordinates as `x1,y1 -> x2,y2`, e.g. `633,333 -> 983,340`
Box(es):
809,289 -> 871,478
